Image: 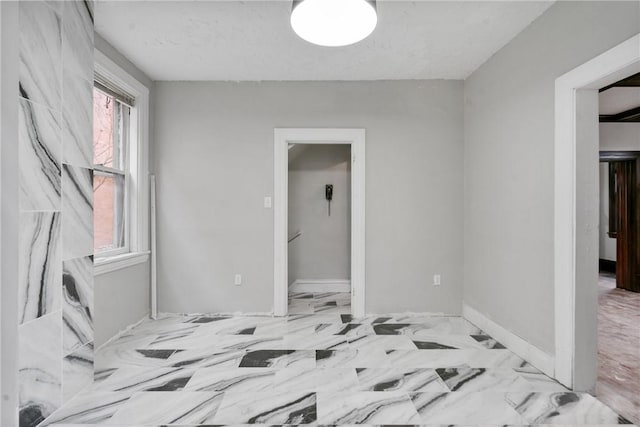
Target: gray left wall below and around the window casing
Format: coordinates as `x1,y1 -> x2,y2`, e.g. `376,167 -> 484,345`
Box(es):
94,34 -> 154,346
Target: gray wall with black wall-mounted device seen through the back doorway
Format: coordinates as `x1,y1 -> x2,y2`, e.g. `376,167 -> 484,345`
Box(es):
288,144 -> 351,284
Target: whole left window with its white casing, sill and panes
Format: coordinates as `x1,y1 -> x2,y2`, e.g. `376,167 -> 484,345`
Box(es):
93,50 -> 149,275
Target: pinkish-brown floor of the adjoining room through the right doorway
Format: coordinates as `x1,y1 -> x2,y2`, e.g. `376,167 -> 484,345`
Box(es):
596,274 -> 640,424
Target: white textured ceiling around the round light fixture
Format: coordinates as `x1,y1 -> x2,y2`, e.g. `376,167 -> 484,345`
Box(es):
95,0 -> 553,80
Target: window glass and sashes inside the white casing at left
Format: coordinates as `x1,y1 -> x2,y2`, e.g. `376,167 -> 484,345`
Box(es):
93,87 -> 130,256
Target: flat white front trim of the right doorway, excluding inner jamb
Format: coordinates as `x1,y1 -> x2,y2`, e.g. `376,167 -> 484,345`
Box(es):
554,34 -> 640,388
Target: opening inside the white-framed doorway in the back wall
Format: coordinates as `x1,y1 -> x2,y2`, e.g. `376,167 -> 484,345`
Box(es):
287,143 -> 351,314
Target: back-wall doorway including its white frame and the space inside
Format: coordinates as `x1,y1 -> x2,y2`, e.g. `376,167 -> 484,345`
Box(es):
273,129 -> 365,318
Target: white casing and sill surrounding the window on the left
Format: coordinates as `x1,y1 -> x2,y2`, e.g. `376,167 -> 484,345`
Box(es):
94,49 -> 149,275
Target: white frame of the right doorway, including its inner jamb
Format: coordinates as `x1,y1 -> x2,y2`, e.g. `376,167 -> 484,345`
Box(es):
554,30 -> 640,412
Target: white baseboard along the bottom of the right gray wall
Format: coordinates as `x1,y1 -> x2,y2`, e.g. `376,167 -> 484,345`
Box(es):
462,304 -> 555,378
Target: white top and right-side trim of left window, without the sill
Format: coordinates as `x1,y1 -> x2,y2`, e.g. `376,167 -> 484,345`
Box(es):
94,49 -> 149,254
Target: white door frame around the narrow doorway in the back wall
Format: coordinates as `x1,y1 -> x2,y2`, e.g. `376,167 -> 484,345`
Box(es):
273,128 -> 365,317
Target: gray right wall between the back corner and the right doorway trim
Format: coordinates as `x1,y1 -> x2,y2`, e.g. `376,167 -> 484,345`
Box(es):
464,2 -> 640,354
